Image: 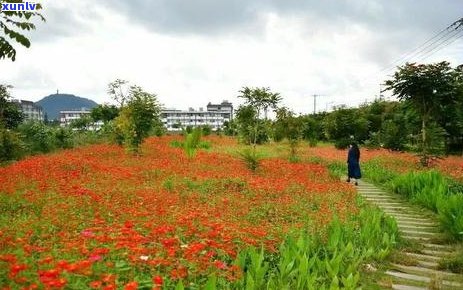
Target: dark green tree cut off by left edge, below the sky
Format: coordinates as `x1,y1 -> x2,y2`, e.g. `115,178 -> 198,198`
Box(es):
0,84 -> 24,129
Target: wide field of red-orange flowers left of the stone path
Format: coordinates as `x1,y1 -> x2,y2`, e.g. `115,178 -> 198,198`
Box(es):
0,137 -> 358,289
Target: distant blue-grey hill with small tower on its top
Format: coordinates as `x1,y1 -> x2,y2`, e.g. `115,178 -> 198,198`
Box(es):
36,94 -> 98,120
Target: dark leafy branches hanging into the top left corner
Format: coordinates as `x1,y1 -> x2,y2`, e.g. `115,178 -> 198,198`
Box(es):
0,0 -> 45,61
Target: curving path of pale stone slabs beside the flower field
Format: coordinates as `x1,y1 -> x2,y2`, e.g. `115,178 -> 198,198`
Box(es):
357,181 -> 463,290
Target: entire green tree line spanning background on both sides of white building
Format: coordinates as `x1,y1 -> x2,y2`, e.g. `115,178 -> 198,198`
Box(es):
0,62 -> 463,165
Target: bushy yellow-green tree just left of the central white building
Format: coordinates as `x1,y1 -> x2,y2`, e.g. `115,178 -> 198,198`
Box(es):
115,86 -> 161,153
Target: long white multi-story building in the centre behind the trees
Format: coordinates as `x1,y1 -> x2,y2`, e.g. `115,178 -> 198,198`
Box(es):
161,101 -> 233,131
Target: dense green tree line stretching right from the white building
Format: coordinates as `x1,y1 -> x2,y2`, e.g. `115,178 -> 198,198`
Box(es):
224,62 -> 463,165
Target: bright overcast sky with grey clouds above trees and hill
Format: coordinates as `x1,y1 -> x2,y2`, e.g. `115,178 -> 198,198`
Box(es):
0,0 -> 463,113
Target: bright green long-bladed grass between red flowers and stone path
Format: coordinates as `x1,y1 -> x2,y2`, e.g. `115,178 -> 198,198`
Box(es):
199,208 -> 398,289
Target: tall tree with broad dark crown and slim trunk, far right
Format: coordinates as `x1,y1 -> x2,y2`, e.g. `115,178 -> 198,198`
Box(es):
386,61 -> 459,165
